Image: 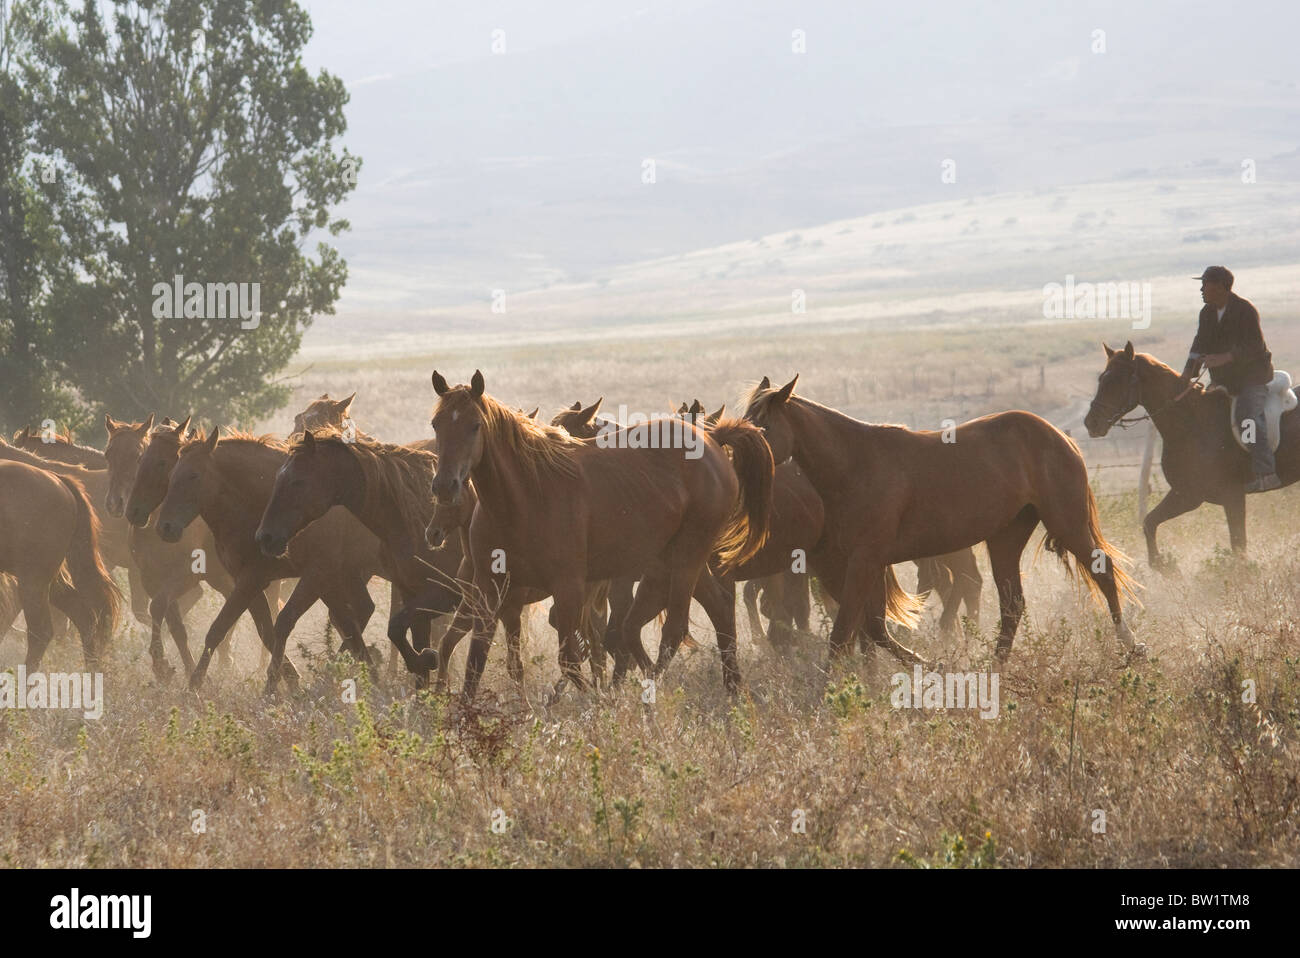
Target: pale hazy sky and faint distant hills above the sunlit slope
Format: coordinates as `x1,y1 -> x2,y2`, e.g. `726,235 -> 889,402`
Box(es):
287,0 -> 1300,343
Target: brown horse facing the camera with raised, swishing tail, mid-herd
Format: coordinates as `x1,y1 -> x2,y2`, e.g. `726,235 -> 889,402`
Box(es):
433,372 -> 772,694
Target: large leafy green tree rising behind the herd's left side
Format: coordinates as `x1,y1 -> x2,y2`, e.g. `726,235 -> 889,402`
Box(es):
16,0 -> 360,421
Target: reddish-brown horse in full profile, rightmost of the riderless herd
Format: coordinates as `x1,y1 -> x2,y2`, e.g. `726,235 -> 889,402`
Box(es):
745,376 -> 1135,663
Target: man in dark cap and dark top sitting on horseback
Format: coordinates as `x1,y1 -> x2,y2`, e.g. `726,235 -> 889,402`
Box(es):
1183,266 -> 1282,493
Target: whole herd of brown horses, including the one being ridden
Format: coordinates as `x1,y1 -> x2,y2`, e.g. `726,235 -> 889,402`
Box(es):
0,343 -> 1284,695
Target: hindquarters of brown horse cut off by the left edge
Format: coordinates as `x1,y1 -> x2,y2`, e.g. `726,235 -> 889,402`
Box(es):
0,460 -> 121,671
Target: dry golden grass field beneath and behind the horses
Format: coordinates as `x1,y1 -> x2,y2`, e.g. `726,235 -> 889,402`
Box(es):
0,320 -> 1300,867
